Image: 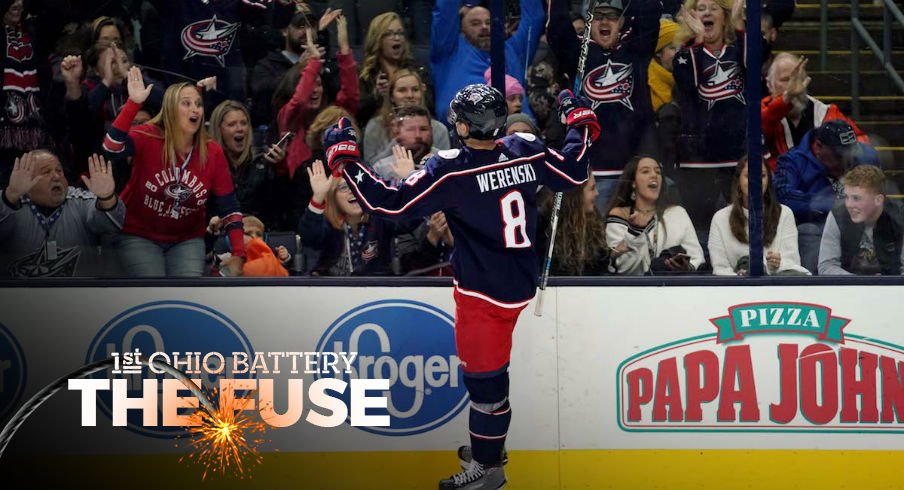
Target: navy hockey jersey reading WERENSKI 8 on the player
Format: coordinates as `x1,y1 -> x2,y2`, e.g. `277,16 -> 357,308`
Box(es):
344,129 -> 587,307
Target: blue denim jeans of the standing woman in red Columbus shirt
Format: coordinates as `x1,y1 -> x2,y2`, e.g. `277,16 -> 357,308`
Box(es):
114,234 -> 204,277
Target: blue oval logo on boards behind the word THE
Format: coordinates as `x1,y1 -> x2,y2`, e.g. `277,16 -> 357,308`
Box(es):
85,301 -> 254,438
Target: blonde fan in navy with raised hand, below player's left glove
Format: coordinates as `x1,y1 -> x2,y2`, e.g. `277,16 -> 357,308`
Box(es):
298,160 -> 392,276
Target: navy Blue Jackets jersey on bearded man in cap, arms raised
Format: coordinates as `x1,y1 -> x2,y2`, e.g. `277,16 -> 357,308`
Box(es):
546,0 -> 662,176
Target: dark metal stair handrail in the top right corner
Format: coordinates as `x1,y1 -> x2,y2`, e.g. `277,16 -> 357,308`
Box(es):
852,0 -> 904,120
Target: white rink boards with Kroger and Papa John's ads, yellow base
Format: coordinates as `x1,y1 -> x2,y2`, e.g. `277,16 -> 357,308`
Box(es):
0,286 -> 904,489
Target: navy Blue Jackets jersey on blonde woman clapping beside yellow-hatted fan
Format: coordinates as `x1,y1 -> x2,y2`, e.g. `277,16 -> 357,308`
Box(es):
672,32 -> 747,168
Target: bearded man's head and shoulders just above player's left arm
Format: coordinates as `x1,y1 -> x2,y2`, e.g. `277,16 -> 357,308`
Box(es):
373,105 -> 439,180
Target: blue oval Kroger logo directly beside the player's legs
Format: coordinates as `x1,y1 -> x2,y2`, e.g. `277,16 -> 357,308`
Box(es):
317,300 -> 468,436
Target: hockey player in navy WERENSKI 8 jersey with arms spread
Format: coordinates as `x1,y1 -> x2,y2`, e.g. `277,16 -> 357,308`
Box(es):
324,85 -> 599,490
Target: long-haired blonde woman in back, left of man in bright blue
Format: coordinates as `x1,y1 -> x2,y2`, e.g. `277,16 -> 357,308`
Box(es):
358,12 -> 433,132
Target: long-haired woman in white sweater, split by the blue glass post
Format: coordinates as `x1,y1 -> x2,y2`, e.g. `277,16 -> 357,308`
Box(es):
708,156 -> 810,276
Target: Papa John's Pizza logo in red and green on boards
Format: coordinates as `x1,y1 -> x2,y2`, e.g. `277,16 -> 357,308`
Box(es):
616,302 -> 904,433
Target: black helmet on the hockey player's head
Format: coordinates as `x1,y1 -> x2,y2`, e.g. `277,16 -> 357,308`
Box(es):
449,83 -> 508,140
